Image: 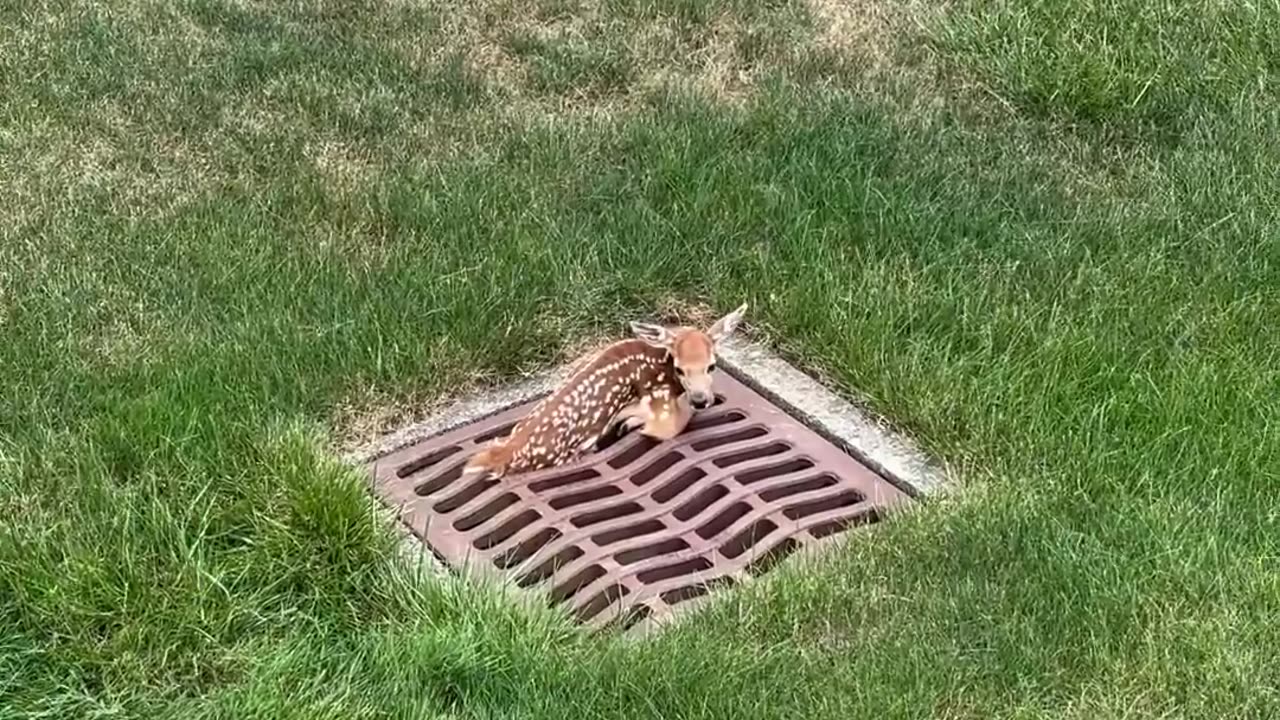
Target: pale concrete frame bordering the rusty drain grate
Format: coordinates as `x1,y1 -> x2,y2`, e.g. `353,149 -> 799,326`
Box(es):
343,337 -> 952,584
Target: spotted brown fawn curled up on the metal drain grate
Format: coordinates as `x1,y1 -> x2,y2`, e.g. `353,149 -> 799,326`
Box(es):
462,304 -> 746,477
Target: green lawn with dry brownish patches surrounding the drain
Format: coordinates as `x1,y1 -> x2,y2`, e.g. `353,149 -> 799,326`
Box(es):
0,0 -> 1280,720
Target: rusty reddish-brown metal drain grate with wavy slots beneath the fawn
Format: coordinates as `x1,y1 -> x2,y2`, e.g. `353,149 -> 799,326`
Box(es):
369,373 -> 908,626
